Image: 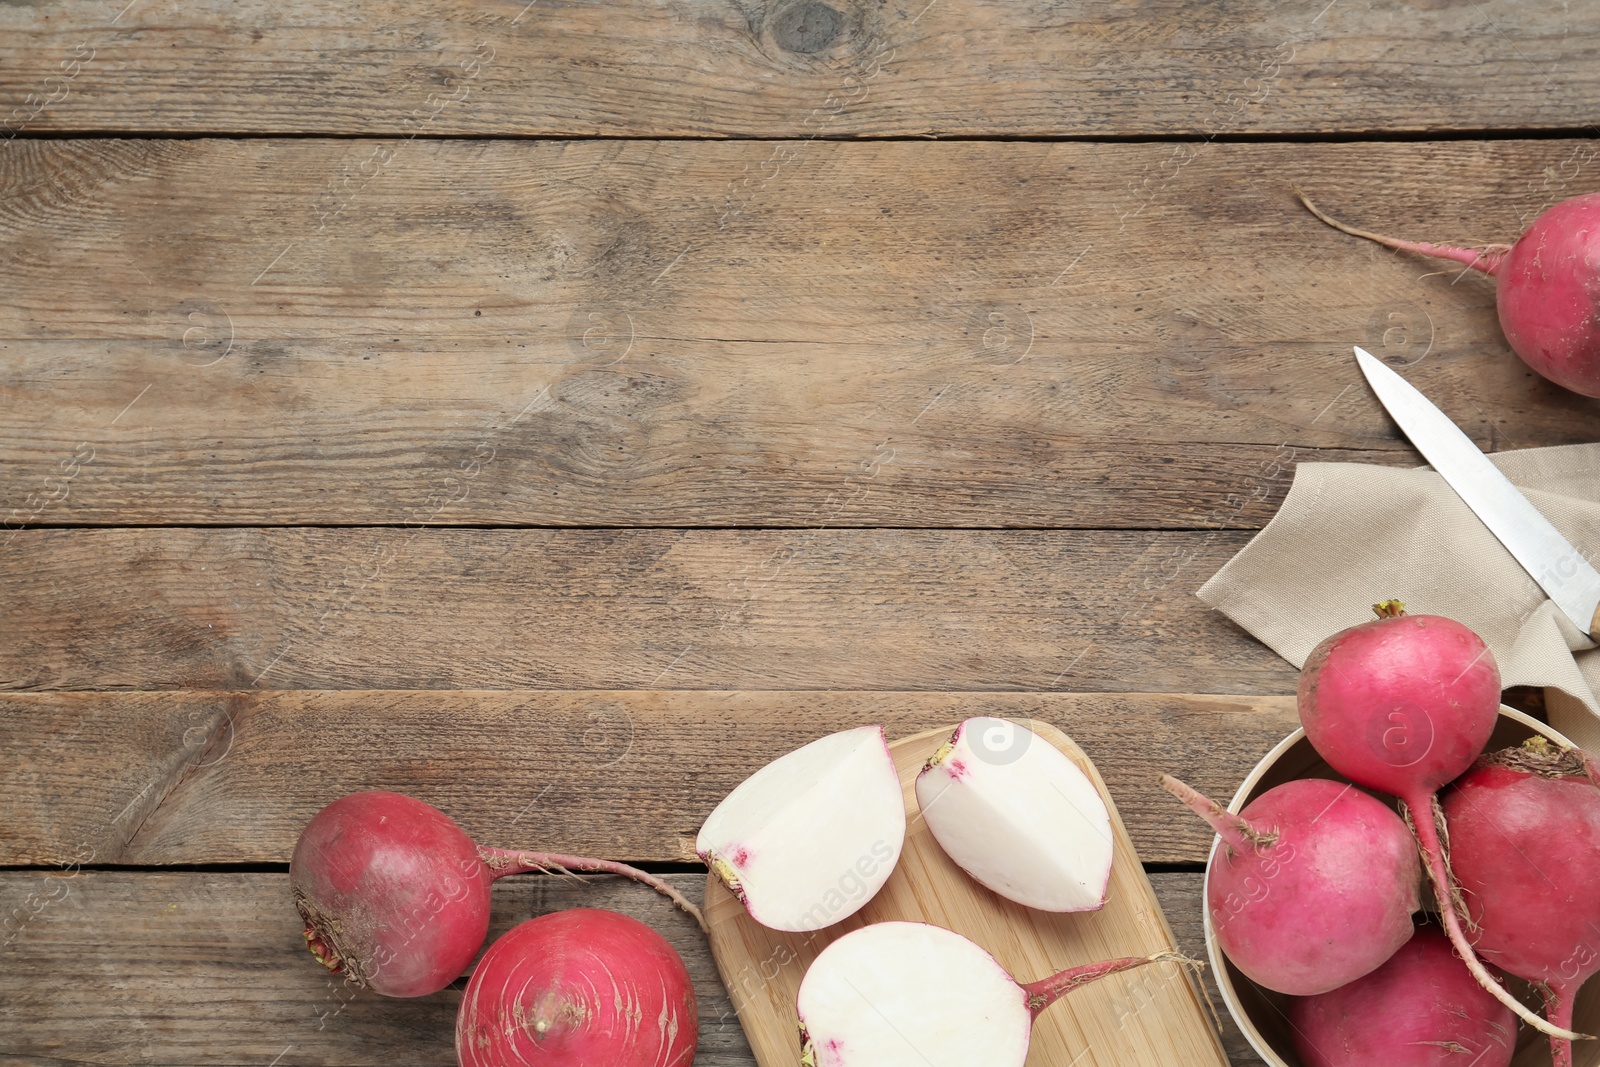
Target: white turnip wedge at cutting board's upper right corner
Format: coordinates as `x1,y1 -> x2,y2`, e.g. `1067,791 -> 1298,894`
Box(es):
917,717 -> 1112,912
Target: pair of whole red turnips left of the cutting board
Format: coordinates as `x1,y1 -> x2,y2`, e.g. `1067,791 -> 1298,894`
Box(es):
290,790 -> 704,1067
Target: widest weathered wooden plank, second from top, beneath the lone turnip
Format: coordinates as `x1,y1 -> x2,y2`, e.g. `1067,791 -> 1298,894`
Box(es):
0,137 -> 1600,528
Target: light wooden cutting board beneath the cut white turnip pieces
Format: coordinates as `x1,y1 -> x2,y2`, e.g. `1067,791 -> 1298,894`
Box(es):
706,720 -> 1227,1067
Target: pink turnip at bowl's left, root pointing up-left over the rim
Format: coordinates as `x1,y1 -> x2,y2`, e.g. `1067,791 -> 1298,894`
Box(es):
1162,774 -> 1422,997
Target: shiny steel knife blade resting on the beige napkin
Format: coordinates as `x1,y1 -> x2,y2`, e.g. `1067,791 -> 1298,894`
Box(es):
1355,349 -> 1600,640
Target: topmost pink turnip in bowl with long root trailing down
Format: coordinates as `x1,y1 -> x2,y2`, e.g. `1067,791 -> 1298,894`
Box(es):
1299,600 -> 1578,1038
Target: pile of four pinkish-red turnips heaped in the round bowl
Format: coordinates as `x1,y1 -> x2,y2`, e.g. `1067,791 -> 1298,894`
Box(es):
1163,601 -> 1600,1067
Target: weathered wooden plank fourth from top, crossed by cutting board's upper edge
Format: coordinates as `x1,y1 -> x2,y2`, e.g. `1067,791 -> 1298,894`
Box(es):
0,689 -> 1298,864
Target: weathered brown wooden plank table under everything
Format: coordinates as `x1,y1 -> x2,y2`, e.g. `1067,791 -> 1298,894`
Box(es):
0,0 -> 1600,1067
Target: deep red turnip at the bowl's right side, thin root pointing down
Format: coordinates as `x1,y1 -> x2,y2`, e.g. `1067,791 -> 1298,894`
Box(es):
1442,737 -> 1600,1067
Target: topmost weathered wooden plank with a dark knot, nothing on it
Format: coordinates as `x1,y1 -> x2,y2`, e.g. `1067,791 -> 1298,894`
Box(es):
0,0 -> 1600,136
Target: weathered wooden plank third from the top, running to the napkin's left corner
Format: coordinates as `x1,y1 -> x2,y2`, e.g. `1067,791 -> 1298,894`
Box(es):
0,528 -> 1299,693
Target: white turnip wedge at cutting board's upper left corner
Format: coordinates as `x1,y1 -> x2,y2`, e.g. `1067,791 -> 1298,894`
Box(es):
694,726 -> 906,933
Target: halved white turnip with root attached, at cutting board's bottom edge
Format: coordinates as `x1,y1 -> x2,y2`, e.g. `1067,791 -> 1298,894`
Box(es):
797,923 -> 1192,1067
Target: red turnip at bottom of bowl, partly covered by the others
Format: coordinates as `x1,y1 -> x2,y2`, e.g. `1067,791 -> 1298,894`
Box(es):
1288,926 -> 1517,1067
